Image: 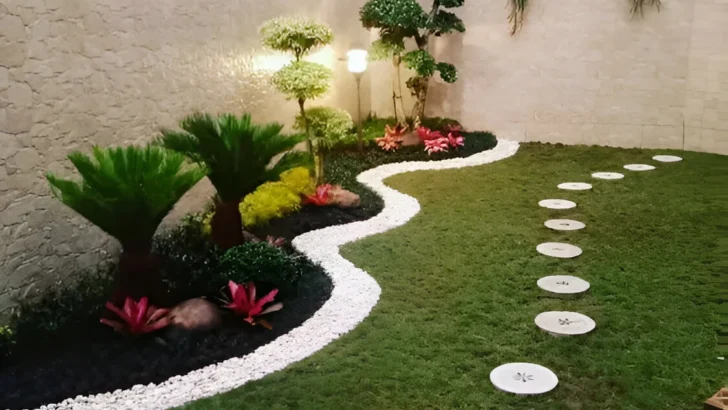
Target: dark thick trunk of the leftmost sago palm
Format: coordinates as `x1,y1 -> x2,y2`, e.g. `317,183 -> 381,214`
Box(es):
111,246 -> 166,306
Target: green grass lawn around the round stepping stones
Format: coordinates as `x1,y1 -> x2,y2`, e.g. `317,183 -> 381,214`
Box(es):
179,144 -> 728,410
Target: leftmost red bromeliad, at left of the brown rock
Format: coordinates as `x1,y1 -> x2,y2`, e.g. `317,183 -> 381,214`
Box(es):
101,296 -> 170,335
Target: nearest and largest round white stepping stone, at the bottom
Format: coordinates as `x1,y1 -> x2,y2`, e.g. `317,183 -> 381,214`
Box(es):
490,363 -> 559,394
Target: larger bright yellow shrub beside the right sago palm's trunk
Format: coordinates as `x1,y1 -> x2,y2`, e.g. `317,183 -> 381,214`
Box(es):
240,182 -> 301,227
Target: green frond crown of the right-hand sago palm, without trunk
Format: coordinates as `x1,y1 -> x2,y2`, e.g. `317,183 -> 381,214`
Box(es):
160,113 -> 302,202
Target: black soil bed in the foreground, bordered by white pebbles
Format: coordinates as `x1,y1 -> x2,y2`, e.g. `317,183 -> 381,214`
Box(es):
0,268 -> 333,409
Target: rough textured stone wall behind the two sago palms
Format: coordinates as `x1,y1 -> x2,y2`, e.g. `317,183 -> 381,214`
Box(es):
0,0 -> 368,312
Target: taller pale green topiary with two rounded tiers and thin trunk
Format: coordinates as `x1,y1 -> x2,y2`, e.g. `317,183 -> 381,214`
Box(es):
260,17 -> 334,153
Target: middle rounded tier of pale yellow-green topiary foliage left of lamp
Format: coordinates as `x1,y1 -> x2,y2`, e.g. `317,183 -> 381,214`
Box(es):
273,61 -> 334,100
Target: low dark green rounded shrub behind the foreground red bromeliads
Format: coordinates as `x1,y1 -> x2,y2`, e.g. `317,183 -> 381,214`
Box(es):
221,242 -> 315,294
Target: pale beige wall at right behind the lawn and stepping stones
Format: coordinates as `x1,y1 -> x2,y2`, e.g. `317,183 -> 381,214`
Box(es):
372,0 -> 728,154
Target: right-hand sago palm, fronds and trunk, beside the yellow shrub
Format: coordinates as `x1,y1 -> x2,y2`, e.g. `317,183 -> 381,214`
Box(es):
161,113 -> 310,250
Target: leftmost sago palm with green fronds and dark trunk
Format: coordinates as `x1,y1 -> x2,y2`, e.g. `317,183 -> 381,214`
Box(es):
47,145 -> 205,305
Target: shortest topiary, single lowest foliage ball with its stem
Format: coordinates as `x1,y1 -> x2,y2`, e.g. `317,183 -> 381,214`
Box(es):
294,107 -> 354,184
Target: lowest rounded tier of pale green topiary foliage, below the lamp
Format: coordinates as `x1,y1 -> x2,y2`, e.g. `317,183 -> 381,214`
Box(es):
294,107 -> 354,147
